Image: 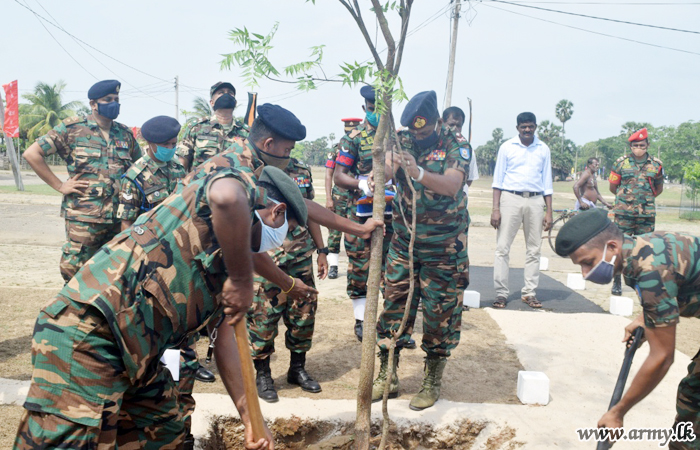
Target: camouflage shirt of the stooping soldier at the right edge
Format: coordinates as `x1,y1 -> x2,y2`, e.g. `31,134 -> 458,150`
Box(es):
622,232 -> 700,327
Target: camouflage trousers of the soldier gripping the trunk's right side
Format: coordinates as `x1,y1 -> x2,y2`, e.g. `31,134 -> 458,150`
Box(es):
377,233 -> 469,356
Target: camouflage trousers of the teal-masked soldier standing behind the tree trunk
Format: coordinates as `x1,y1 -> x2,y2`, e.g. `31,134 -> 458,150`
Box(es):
345,207 -> 394,299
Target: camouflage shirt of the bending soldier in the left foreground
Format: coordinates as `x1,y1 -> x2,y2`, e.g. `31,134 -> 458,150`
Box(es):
53,167 -> 267,382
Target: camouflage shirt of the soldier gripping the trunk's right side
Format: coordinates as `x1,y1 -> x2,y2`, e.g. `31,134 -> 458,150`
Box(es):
393,126 -> 472,246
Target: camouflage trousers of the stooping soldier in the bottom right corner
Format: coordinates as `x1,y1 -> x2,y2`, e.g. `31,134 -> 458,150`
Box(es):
668,352 -> 700,450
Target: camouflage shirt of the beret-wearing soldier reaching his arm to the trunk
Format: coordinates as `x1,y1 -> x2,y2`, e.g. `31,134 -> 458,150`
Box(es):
270,158 -> 316,265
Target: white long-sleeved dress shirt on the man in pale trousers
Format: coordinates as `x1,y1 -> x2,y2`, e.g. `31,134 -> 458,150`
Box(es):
491,136 -> 554,195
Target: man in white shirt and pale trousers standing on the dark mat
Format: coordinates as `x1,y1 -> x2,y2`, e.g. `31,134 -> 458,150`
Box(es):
491,112 -> 554,308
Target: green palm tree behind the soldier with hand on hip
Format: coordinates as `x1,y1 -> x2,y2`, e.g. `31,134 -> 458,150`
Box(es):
19,80 -> 85,141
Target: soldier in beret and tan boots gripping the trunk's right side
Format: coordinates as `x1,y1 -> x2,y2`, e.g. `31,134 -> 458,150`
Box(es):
372,91 -> 471,410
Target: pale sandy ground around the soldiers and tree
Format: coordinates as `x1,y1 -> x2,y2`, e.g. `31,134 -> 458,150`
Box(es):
0,170 -> 700,448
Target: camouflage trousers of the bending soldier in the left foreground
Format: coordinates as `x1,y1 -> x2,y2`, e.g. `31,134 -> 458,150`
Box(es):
14,299 -> 185,450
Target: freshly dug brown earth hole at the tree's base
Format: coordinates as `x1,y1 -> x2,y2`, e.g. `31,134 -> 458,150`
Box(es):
202,416 -> 520,450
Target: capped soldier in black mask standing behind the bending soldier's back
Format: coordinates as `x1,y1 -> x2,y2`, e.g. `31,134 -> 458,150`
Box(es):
176,81 -> 248,172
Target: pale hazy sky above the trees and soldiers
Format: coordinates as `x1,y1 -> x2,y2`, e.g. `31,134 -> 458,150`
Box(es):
0,0 -> 700,146
